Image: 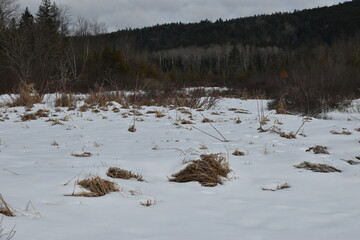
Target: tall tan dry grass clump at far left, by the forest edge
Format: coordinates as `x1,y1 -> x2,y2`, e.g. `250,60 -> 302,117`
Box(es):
8,83 -> 42,107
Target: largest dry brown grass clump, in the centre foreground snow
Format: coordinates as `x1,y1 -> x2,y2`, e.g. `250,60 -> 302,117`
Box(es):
169,154 -> 231,187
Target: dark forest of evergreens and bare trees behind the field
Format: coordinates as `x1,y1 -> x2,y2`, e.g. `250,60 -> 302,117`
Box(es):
0,0 -> 360,112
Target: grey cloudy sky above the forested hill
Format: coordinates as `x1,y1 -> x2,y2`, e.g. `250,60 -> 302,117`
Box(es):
18,0 -> 345,31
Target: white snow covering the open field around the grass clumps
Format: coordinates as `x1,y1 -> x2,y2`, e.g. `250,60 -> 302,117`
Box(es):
0,94 -> 360,240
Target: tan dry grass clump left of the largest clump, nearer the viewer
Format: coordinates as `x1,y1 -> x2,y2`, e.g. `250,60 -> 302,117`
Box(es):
67,176 -> 119,197
